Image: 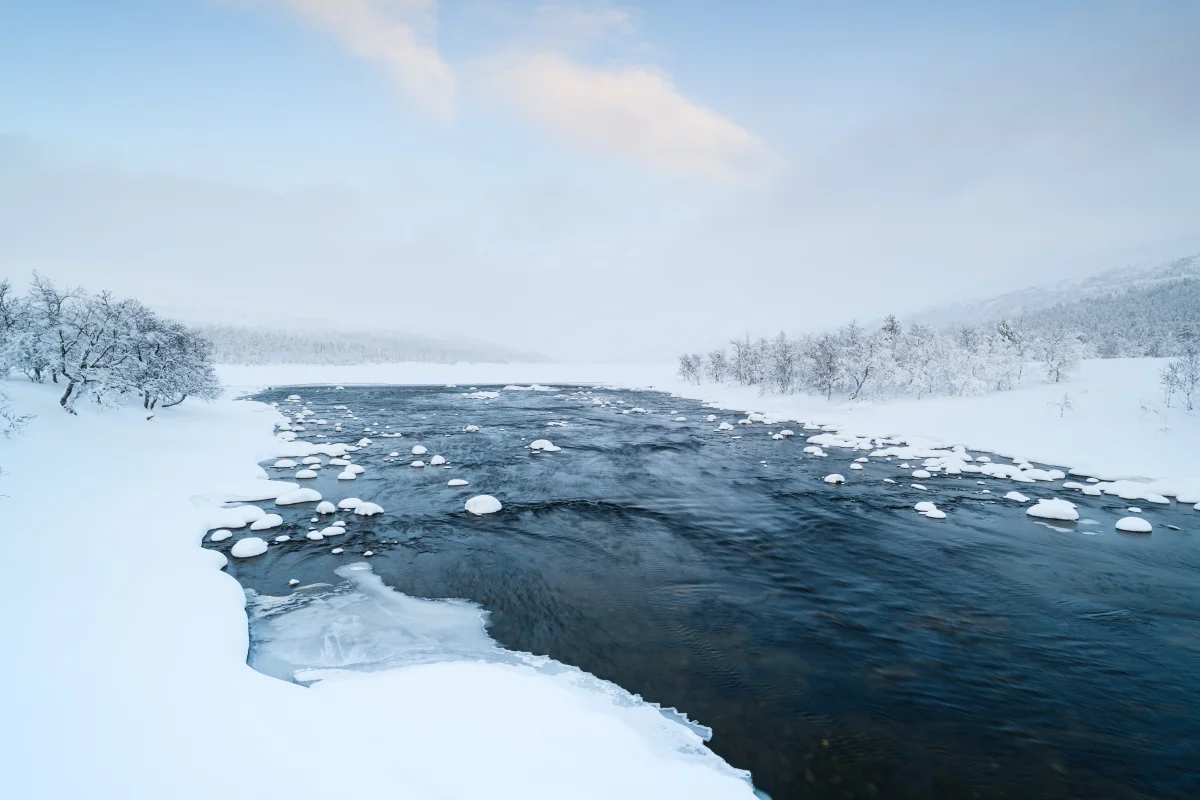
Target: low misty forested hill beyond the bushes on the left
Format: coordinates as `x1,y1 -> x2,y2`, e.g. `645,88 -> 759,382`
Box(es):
193,324 -> 551,365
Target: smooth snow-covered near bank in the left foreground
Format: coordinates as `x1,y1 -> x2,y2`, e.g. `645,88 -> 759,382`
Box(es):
0,380 -> 752,798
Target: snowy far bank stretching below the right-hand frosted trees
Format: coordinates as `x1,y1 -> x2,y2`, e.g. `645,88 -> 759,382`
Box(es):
217,359 -> 1200,503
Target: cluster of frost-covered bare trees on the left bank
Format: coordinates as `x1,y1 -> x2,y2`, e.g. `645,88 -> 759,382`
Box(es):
0,273 -> 221,413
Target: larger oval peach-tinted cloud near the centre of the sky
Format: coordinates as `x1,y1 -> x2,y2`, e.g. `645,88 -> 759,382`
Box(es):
485,53 -> 768,181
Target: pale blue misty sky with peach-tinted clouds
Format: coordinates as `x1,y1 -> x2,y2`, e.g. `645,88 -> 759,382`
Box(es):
0,0 -> 1200,361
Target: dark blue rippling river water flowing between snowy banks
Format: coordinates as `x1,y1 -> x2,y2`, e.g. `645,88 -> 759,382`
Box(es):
210,386 -> 1200,800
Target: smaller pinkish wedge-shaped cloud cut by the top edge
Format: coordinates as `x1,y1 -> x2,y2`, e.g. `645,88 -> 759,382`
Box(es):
267,0 -> 455,119
